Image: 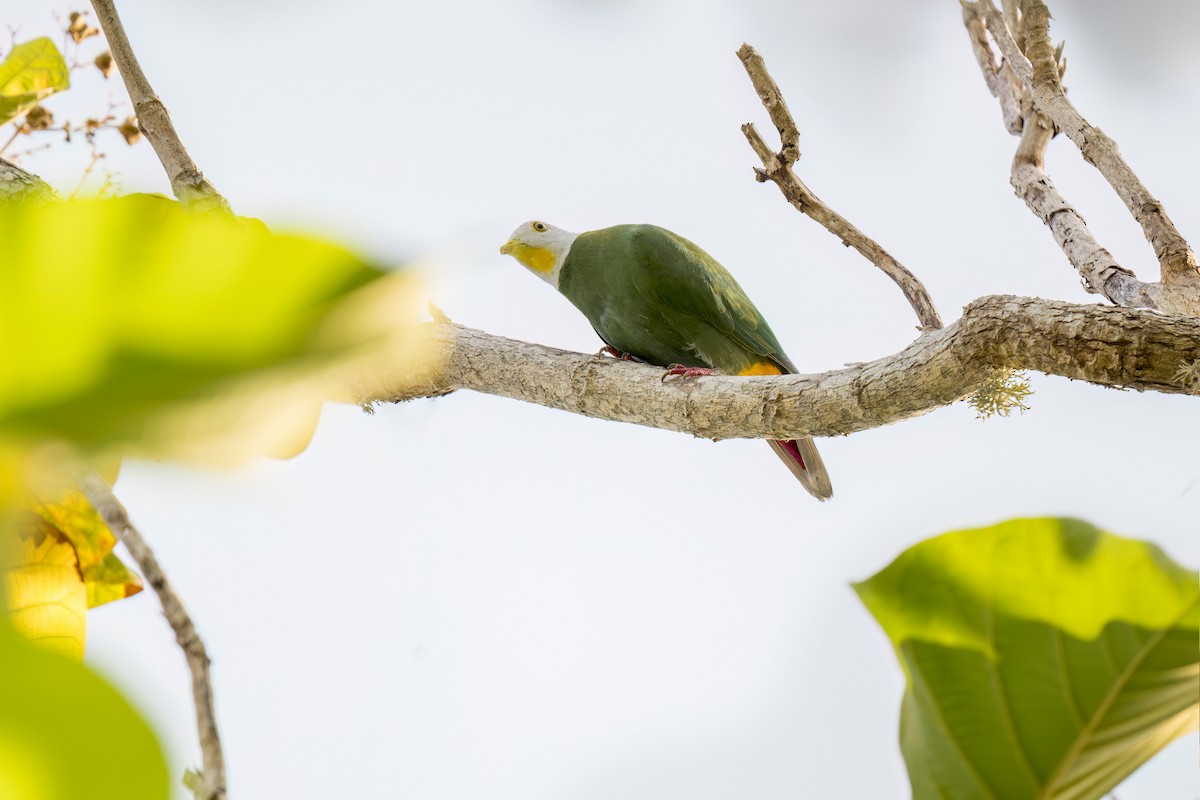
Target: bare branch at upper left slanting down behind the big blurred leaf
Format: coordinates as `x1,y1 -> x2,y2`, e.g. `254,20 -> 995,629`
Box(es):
91,0 -> 229,211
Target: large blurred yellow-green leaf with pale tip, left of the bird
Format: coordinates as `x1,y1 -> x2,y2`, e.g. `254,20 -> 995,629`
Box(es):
0,196 -> 429,459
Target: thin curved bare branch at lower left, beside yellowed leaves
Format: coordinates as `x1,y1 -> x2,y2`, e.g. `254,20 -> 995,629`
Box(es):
79,473 -> 226,800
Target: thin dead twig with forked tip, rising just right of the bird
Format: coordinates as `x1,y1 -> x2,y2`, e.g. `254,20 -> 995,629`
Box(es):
738,44 -> 942,330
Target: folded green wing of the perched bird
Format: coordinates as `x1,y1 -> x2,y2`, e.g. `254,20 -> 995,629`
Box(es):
634,225 -> 797,372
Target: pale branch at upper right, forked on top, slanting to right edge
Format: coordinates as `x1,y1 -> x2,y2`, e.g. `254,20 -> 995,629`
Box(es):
979,0 -> 1200,315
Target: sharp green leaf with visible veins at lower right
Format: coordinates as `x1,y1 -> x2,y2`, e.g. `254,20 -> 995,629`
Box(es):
854,519 -> 1200,800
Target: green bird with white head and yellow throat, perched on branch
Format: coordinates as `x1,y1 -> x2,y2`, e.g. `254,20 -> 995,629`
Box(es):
500,219 -> 833,500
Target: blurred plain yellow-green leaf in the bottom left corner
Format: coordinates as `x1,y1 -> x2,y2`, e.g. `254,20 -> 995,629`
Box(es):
0,615 -> 169,800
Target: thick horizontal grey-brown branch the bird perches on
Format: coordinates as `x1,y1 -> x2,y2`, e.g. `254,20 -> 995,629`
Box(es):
379,295 -> 1200,439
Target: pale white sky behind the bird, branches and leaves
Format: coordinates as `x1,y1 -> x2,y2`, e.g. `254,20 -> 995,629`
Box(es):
0,0 -> 1200,800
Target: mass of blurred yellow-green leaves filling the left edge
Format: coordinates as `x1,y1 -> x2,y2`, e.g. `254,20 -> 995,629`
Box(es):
0,185 -> 425,800
